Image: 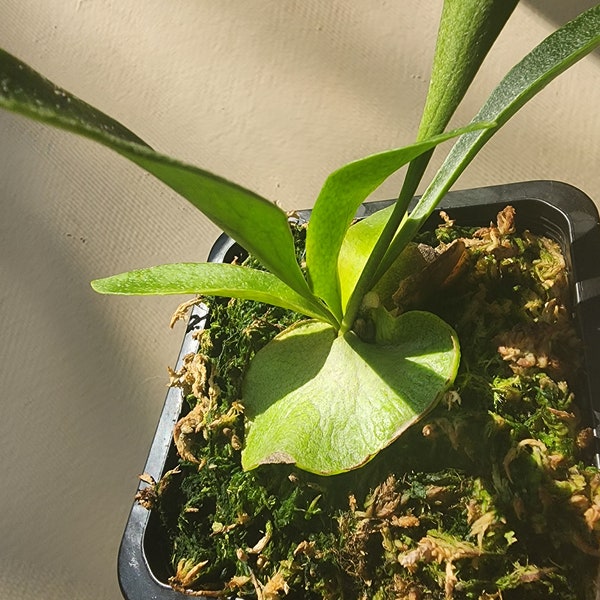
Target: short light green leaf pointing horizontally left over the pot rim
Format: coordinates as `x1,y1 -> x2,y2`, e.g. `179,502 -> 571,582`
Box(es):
92,263 -> 335,324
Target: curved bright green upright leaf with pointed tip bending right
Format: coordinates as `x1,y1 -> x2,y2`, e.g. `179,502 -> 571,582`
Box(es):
306,122 -> 494,319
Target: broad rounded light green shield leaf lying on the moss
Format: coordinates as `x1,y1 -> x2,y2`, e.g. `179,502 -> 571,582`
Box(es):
242,311 -> 459,475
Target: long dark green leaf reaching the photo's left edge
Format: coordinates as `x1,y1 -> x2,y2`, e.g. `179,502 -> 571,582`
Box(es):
0,50 -> 310,304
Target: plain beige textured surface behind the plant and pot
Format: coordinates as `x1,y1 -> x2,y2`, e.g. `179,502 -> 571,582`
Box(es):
0,0 -> 600,600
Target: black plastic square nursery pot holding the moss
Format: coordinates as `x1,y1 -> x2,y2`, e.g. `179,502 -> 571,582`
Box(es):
118,181 -> 600,600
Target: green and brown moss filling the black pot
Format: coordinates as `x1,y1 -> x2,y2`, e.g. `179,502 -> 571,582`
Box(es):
144,211 -> 600,600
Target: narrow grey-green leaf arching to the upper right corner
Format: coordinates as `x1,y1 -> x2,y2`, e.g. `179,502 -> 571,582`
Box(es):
376,4 -> 600,278
